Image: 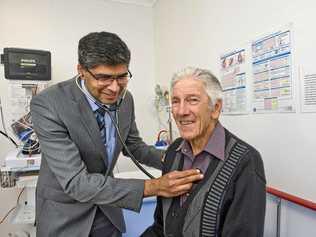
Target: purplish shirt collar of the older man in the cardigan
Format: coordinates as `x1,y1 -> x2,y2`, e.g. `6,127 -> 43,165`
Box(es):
176,122 -> 225,160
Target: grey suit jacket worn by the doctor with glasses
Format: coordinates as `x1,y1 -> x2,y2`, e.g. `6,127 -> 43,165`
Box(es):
31,78 -> 161,237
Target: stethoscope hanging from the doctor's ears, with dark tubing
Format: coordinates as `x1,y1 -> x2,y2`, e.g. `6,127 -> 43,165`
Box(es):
75,75 -> 155,179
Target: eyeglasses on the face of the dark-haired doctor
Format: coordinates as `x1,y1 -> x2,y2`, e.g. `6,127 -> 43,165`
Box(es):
86,68 -> 132,85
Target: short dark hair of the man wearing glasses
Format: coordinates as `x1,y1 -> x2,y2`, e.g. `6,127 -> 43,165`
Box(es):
78,31 -> 131,69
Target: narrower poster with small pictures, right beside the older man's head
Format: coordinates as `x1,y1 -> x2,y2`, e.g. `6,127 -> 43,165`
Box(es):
220,49 -> 249,114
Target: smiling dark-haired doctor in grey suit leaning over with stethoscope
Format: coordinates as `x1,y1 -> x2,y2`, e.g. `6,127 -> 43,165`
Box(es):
31,32 -> 202,237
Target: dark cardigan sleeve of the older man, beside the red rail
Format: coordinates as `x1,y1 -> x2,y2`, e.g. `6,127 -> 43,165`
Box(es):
222,151 -> 266,237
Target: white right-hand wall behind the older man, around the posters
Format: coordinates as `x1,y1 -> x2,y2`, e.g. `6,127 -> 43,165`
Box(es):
154,0 -> 316,237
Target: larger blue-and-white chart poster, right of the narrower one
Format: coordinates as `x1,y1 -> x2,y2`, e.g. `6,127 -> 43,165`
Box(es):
251,27 -> 295,113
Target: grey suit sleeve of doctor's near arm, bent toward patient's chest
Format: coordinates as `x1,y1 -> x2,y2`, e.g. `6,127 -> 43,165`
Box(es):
31,94 -> 144,211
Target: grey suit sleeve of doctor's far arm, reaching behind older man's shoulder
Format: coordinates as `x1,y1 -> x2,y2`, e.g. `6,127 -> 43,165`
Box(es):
123,92 -> 164,170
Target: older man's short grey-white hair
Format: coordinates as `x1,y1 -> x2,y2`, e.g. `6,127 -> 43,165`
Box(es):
170,67 -> 223,108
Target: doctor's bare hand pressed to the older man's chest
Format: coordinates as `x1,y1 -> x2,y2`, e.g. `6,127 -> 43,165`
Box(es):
144,169 -> 203,197
